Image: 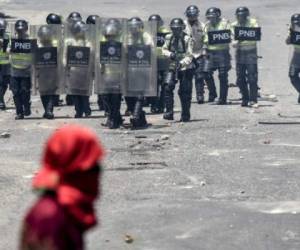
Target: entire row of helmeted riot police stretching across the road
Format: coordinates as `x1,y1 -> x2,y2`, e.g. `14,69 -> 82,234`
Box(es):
0,5 -> 300,128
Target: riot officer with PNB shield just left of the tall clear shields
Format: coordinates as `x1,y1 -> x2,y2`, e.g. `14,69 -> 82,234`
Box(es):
10,20 -> 34,120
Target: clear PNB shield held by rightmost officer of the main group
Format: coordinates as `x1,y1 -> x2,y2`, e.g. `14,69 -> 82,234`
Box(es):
232,17 -> 262,64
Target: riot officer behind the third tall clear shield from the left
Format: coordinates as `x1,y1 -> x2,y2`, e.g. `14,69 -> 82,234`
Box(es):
95,18 -> 126,129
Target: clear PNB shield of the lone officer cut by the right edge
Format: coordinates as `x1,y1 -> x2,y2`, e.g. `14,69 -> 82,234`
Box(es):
289,27 -> 300,69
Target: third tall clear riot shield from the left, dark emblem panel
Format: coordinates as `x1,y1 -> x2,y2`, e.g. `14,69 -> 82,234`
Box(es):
95,18 -> 126,94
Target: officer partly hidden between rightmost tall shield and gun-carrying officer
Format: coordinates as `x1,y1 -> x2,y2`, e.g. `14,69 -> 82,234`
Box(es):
148,14 -> 170,114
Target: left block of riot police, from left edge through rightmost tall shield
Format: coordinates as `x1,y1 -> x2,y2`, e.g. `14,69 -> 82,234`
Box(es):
0,12 -> 157,128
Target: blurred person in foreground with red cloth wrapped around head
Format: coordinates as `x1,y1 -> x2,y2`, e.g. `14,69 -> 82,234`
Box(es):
20,125 -> 104,250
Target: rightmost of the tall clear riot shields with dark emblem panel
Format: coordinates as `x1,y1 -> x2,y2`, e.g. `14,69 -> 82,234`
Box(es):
125,22 -> 157,96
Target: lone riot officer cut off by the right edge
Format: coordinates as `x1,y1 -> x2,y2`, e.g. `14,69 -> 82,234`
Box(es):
286,13 -> 300,104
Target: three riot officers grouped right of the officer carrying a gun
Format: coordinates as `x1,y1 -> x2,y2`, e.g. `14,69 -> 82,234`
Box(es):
185,5 -> 261,109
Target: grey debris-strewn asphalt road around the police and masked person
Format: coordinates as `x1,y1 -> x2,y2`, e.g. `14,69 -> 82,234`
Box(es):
0,0 -> 300,250
